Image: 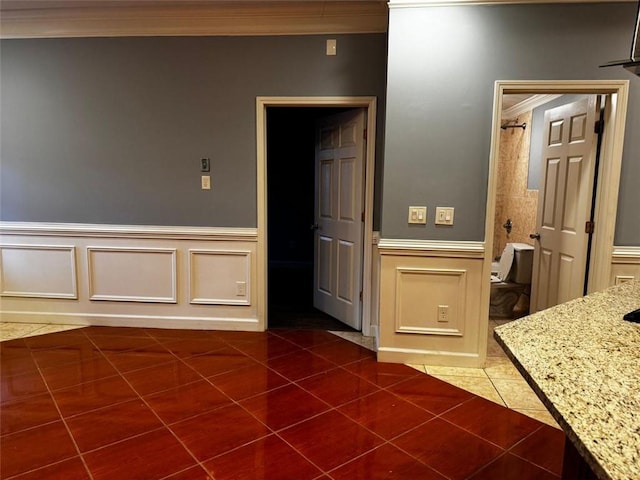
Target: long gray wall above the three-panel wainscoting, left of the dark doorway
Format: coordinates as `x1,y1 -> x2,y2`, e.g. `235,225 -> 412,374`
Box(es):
0,34 -> 386,227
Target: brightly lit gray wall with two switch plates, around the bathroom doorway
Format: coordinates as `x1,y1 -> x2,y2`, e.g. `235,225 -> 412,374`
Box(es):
382,3 -> 640,245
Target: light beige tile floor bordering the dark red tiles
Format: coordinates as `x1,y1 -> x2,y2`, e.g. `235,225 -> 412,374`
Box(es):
0,320 -> 559,428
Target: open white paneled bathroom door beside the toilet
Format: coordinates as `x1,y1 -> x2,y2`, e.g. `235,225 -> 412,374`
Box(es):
531,95 -> 598,312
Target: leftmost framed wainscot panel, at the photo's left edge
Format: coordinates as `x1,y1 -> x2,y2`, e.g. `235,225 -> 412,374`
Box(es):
0,244 -> 78,299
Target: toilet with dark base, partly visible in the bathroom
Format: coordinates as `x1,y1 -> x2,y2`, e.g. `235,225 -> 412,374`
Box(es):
489,243 -> 534,318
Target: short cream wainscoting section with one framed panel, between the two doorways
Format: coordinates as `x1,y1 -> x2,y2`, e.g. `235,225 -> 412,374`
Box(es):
378,239 -> 489,367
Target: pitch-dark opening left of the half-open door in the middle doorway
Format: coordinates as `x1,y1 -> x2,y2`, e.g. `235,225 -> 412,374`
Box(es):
267,107 -> 355,331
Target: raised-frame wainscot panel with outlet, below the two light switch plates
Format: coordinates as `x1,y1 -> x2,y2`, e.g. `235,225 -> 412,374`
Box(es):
395,267 -> 467,336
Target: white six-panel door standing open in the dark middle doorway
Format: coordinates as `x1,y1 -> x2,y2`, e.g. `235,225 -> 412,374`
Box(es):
313,109 -> 365,330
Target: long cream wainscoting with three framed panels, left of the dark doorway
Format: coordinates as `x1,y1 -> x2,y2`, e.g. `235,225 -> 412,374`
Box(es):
0,222 -> 264,330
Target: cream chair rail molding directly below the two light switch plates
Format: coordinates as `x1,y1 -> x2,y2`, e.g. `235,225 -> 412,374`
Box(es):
378,238 -> 485,258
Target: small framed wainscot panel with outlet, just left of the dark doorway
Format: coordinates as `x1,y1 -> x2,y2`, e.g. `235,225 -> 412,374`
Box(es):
189,250 -> 251,305
